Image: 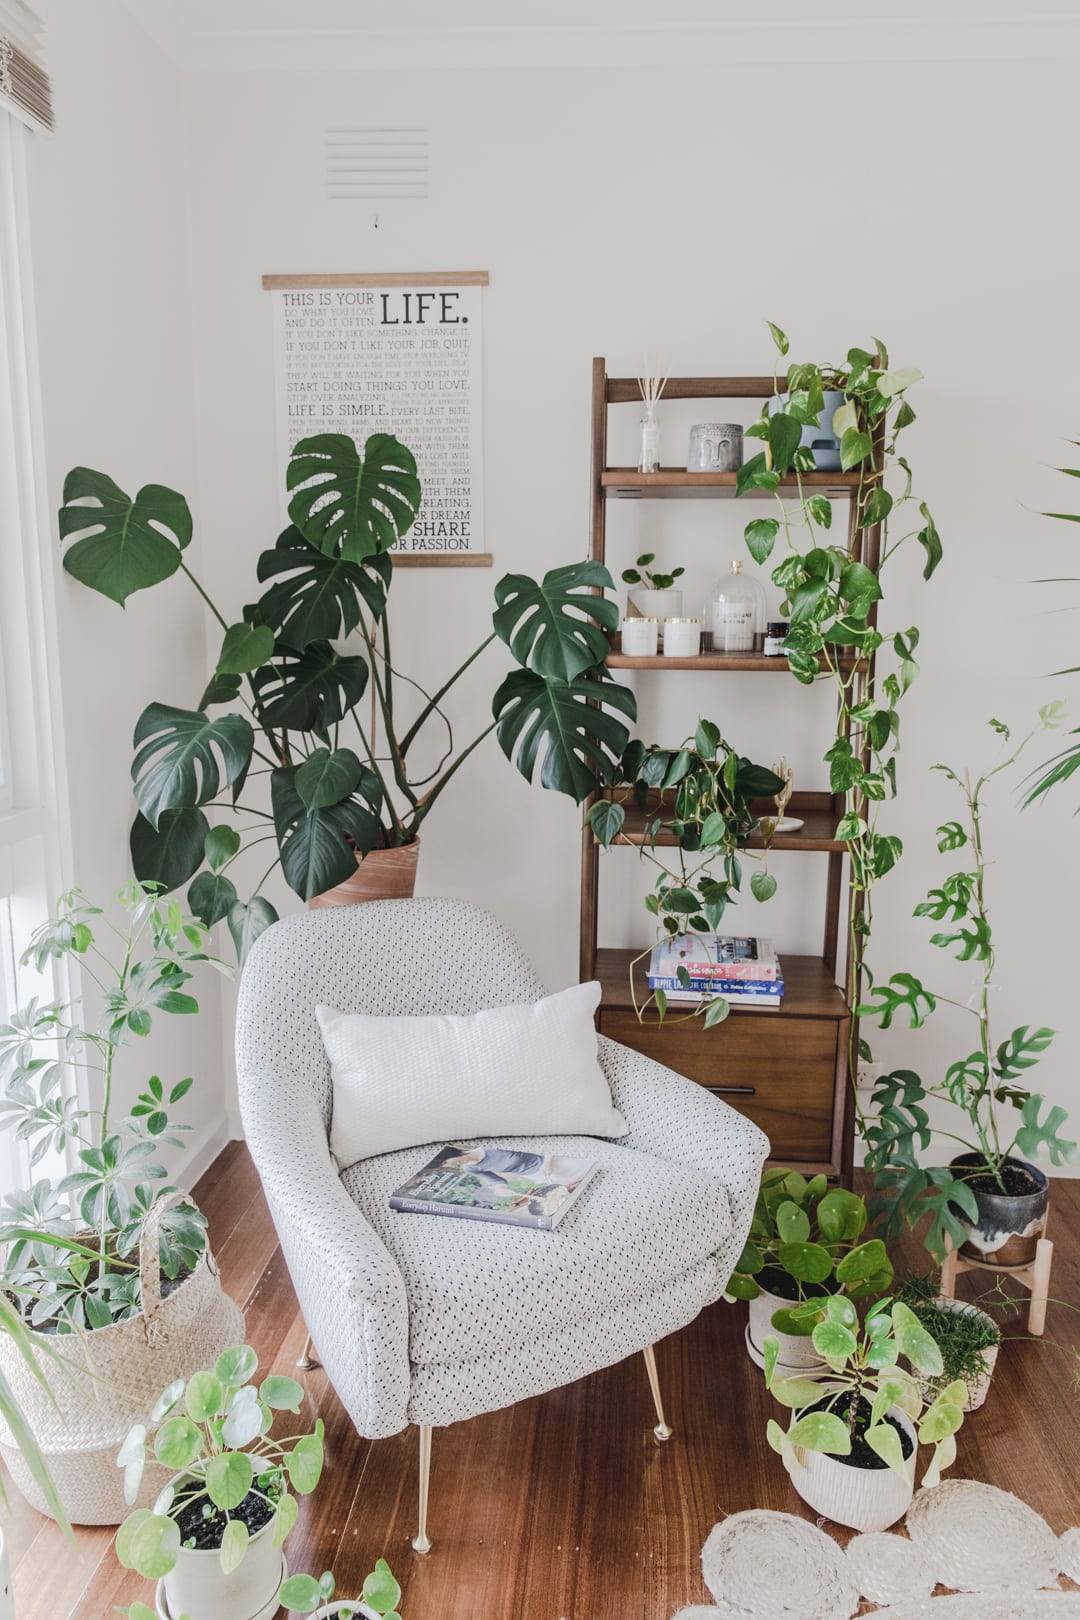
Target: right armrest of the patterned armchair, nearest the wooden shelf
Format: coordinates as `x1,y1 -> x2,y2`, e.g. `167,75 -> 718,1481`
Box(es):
599,1035 -> 769,1249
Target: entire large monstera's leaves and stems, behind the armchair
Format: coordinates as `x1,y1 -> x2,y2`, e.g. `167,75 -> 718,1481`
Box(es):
60,434 -> 635,957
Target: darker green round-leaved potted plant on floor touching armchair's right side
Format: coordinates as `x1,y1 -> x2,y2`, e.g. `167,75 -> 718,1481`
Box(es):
725,1170 -> 892,1374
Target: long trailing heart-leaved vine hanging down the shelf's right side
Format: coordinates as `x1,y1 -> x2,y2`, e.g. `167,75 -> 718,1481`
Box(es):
737,322 -> 942,1077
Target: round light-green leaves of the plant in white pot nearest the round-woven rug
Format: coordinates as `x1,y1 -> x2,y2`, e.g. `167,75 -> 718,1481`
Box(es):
764,1294 -> 967,1486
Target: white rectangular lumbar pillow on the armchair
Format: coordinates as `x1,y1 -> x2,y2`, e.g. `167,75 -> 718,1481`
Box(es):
316,983 -> 630,1170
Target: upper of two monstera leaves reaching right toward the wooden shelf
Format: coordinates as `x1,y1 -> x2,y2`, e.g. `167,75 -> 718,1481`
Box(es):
492,562 -> 619,682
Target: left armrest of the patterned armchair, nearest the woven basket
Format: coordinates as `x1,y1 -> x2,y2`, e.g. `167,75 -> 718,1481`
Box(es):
240,1064 -> 411,1439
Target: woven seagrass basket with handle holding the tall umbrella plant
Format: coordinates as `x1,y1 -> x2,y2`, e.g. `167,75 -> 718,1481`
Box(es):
0,1192 -> 244,1524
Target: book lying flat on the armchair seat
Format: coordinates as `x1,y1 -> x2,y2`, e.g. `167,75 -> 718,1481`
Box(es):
390,1145 -> 599,1231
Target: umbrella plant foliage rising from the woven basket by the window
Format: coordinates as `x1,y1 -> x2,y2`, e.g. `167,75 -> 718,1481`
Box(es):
0,883 -> 220,1333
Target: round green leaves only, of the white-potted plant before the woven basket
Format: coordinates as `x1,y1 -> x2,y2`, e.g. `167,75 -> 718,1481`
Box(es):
117,1345 -> 324,1581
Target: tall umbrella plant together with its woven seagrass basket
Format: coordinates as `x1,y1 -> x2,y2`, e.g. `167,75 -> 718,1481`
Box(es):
0,883 -> 243,1524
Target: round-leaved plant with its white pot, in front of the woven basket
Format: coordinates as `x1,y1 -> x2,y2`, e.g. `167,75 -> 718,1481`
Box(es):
117,1345 -> 324,1620
